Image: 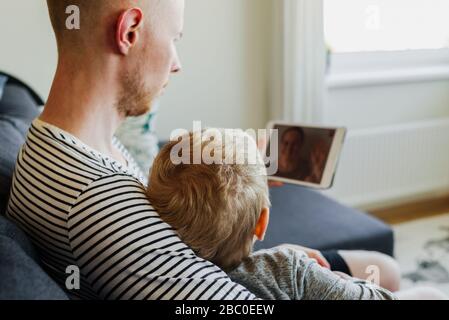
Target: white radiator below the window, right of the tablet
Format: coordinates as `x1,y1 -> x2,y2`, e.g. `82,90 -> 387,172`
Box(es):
324,118 -> 449,208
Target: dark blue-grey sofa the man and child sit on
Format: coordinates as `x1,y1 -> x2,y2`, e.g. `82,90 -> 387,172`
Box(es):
0,73 -> 393,300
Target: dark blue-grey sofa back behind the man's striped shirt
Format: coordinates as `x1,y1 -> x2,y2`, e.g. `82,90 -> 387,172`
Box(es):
0,72 -> 67,300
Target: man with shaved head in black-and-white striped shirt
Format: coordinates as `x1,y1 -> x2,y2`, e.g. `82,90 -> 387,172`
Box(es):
8,0 -> 397,299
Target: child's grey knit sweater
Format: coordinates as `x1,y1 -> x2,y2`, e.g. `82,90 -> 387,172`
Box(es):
229,247 -> 396,300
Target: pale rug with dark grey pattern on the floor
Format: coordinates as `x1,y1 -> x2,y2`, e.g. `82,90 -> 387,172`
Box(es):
393,214 -> 449,294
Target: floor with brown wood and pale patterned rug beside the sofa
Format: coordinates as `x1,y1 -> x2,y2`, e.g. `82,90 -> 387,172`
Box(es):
370,197 -> 449,295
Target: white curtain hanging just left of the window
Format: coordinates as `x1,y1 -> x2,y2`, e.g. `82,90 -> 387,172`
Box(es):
271,0 -> 326,124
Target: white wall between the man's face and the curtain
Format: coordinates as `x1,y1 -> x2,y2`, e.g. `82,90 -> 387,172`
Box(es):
158,0 -> 272,136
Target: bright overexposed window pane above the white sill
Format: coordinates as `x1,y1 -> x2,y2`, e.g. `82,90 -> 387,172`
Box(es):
324,0 -> 449,53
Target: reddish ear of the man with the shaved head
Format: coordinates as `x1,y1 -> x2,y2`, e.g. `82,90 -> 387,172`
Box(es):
116,8 -> 144,55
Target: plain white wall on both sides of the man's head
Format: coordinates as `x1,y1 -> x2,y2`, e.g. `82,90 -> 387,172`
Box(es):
0,0 -> 273,138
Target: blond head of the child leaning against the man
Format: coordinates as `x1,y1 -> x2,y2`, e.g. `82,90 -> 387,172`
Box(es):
147,129 -> 270,270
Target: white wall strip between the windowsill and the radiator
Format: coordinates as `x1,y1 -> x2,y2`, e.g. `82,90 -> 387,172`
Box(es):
325,81 -> 449,129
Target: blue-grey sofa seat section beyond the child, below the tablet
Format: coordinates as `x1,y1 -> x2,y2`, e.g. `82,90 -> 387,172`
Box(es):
256,185 -> 394,255
